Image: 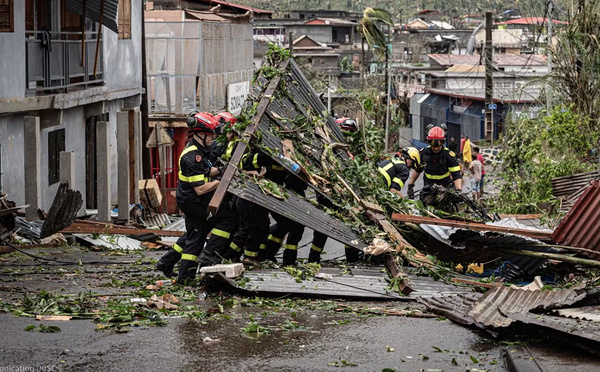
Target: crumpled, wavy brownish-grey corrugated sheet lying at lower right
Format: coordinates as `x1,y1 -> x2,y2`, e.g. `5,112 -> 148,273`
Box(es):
467,284 -> 586,327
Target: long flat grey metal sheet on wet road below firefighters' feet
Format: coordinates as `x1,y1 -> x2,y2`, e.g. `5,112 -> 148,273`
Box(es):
212,267 -> 470,301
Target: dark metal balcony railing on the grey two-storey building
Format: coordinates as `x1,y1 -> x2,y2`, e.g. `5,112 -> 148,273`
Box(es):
25,31 -> 104,94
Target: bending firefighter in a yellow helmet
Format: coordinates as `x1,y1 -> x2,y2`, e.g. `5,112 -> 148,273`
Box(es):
377,147 -> 421,197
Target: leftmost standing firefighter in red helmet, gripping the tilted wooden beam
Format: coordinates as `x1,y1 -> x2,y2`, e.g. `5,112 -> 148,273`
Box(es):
172,112 -> 226,283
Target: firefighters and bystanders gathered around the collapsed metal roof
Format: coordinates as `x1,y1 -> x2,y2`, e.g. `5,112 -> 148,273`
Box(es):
156,112 -> 484,283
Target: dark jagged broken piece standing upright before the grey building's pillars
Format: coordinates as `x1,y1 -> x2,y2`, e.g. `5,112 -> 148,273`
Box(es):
40,183 -> 83,238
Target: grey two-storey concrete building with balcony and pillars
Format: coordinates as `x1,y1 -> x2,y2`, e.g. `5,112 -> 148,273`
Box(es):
0,0 -> 143,219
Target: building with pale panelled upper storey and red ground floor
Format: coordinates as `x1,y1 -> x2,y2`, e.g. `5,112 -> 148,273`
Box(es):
145,4 -> 254,213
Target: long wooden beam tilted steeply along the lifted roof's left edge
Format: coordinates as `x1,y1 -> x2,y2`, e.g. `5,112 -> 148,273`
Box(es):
208,59 -> 290,215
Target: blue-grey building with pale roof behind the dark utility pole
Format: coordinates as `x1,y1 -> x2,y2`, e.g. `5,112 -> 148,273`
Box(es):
410,54 -> 548,146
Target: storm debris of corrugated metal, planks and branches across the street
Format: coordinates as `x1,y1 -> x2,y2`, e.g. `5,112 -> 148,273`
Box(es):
0,44 -> 600,358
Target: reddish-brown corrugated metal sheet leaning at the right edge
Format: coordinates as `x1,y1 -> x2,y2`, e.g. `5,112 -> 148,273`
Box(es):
552,180 -> 600,259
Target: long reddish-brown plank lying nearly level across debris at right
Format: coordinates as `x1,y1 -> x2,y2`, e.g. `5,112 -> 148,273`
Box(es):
392,213 -> 552,242
